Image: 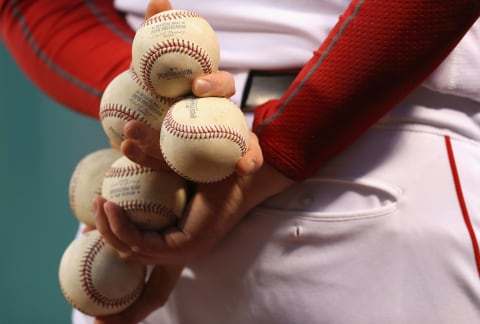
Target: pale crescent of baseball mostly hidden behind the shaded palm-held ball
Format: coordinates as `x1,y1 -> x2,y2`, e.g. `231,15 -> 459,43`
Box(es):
68,148 -> 122,227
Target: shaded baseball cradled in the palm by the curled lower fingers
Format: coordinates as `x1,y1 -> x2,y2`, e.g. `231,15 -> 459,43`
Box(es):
102,156 -> 187,230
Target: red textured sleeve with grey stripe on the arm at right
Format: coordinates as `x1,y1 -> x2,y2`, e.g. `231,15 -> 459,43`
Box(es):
254,0 -> 480,180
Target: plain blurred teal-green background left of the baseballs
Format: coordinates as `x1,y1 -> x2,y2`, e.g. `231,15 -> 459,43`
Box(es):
0,42 -> 108,324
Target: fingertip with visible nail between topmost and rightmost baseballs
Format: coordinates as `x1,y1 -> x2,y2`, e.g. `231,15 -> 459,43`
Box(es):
192,71 -> 235,98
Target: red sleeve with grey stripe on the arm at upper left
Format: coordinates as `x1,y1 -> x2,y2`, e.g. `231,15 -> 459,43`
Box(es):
0,0 -> 134,118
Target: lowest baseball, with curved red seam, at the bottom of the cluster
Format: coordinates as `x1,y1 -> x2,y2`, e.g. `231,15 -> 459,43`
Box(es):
58,230 -> 146,316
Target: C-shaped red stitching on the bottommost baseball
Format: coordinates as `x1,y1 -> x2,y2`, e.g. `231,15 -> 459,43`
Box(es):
80,237 -> 143,308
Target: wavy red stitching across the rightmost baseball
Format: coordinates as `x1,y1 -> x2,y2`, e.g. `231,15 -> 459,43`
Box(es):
163,109 -> 247,155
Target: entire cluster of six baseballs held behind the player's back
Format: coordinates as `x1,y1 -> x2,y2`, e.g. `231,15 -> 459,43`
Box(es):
59,10 -> 249,316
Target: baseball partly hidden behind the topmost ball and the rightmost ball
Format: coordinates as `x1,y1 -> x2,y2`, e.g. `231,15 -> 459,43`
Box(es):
99,69 -> 177,146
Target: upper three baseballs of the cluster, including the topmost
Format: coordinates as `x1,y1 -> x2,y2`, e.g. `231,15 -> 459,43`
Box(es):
100,10 -> 249,182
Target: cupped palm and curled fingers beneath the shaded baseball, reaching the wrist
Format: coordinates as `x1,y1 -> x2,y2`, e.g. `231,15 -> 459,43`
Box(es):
95,158 -> 294,264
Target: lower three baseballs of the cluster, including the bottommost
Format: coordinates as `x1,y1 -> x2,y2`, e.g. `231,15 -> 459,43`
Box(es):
59,149 -> 191,316
